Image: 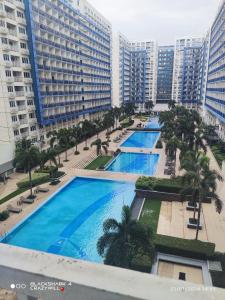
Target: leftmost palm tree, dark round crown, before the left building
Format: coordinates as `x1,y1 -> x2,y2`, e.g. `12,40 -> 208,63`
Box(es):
14,139 -> 40,198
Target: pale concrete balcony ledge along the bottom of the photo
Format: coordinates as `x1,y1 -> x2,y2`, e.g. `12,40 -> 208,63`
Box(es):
0,244 -> 225,300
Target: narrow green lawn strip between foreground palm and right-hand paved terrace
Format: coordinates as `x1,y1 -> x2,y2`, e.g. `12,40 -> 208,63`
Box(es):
140,199 -> 161,234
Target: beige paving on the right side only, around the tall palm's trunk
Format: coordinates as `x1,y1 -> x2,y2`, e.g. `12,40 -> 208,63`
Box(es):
157,147 -> 225,252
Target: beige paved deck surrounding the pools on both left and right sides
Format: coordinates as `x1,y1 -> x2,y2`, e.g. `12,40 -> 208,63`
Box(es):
0,118 -> 225,252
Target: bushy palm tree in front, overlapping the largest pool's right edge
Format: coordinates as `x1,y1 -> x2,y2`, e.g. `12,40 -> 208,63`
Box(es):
97,206 -> 154,269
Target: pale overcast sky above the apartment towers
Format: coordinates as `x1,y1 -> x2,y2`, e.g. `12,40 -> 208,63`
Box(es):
89,0 -> 221,45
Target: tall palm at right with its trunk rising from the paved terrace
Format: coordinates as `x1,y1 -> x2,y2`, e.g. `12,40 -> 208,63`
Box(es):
181,152 -> 222,240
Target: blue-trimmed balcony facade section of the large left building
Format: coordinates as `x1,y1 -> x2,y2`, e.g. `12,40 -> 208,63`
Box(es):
24,0 -> 111,126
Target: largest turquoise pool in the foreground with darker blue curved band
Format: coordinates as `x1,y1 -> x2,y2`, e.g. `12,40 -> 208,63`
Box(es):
2,177 -> 135,262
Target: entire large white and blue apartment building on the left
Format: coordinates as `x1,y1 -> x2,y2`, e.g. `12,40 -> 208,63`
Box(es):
0,0 -> 112,175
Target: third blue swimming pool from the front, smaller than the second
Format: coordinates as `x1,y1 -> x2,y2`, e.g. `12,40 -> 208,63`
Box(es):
120,131 -> 160,149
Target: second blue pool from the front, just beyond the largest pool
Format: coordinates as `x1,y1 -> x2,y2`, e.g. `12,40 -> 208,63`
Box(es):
107,152 -> 159,176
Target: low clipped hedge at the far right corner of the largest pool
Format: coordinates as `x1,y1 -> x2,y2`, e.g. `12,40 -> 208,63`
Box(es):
136,176 -> 183,194
